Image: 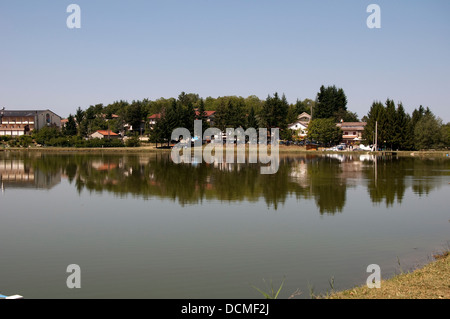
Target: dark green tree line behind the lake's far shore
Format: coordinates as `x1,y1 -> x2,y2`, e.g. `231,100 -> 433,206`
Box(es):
4,85 -> 450,150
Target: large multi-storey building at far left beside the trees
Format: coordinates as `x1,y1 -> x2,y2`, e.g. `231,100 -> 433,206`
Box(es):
0,109 -> 61,136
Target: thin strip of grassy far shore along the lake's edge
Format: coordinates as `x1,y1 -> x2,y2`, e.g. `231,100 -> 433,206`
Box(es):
0,145 -> 450,159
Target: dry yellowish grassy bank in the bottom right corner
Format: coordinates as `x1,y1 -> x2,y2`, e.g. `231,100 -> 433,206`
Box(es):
327,251 -> 450,299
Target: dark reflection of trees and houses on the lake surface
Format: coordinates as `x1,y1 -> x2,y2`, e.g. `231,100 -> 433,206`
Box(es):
0,152 -> 450,214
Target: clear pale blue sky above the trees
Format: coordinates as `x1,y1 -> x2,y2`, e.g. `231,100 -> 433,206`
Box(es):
0,0 -> 450,122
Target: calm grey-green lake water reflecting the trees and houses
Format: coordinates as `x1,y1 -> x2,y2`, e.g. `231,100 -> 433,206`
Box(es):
0,152 -> 450,298
